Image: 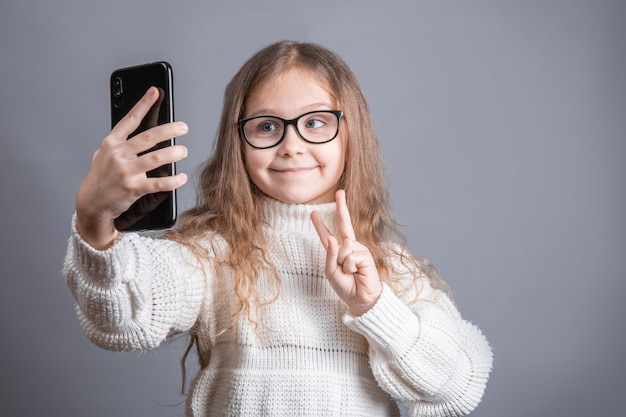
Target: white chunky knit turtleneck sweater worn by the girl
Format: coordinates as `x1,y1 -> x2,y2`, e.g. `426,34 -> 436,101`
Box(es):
64,200 -> 492,417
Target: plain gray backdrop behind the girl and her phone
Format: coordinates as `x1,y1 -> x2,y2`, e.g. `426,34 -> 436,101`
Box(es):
0,0 -> 626,417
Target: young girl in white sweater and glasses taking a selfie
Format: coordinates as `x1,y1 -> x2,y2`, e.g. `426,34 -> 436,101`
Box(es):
64,42 -> 492,417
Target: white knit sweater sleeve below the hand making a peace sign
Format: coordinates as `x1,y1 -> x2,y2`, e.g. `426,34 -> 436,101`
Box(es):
344,284 -> 492,417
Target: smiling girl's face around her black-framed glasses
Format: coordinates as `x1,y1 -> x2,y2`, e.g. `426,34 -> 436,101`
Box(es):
244,69 -> 345,204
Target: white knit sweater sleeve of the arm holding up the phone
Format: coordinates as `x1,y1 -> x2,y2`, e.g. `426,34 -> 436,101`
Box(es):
63,214 -> 206,351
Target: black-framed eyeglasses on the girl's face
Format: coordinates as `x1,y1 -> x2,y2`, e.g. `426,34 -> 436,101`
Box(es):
237,110 -> 343,149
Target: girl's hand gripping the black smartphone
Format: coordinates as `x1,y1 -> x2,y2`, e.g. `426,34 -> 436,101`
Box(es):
76,87 -> 188,249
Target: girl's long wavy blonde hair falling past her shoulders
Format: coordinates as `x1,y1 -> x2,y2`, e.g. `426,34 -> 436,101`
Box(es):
166,41 -> 444,348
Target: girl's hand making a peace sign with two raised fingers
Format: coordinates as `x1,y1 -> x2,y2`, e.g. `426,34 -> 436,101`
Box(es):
311,190 -> 382,316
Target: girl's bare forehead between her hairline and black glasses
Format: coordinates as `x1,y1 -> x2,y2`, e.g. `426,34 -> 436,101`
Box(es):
244,68 -> 338,117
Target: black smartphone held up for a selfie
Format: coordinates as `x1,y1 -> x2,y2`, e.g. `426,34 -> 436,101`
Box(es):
110,61 -> 177,231
